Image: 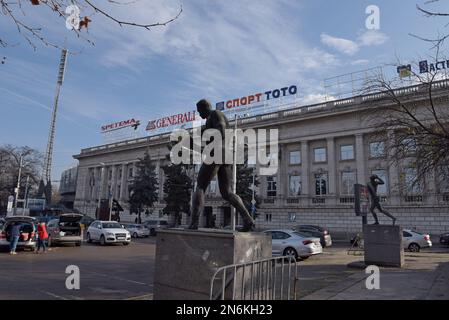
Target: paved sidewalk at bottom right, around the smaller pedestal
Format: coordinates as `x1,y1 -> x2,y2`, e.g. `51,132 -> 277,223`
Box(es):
302,253 -> 449,300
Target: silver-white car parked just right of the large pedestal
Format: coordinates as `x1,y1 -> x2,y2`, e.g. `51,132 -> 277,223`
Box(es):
264,230 -> 323,259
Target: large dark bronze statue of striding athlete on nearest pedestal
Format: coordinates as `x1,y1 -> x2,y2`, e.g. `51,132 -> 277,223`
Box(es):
189,99 -> 255,232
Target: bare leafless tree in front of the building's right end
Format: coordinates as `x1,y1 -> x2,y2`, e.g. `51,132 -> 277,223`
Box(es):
365,57 -> 449,195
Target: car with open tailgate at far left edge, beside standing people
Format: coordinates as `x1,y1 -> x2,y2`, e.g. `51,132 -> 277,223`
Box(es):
0,216 -> 37,250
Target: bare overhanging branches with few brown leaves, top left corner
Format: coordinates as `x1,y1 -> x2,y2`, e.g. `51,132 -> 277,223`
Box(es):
0,0 -> 182,49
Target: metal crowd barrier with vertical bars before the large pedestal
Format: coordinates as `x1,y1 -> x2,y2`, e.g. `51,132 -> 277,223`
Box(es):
210,256 -> 298,300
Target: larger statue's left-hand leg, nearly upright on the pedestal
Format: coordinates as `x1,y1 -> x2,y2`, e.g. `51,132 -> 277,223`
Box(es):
189,164 -> 218,230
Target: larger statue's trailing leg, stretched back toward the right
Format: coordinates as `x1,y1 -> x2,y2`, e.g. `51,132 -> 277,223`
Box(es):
218,164 -> 255,231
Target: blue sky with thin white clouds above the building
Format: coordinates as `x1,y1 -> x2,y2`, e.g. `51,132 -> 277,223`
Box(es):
0,0 -> 449,184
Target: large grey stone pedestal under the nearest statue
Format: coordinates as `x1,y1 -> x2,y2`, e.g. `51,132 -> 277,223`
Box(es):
154,229 -> 271,300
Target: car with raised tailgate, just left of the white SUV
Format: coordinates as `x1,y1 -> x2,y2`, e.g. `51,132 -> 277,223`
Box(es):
47,213 -> 83,247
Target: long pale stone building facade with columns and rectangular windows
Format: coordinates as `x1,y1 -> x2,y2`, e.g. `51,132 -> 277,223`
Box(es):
74,80 -> 449,236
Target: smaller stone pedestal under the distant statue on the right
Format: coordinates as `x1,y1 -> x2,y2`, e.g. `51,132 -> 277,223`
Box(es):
363,225 -> 404,268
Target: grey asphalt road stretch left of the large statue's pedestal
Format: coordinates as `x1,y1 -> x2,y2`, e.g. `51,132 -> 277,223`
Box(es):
0,237 -> 156,300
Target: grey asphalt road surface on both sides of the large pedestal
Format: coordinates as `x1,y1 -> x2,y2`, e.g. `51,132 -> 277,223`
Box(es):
0,237 -> 449,300
